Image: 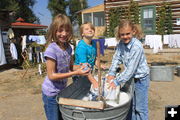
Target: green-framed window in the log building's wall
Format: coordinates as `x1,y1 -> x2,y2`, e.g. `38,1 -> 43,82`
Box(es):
141,6 -> 155,34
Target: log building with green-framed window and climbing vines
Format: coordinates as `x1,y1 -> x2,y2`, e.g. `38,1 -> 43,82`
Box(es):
104,0 -> 180,34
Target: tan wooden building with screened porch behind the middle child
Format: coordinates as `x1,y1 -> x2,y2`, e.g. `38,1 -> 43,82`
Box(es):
78,4 -> 105,38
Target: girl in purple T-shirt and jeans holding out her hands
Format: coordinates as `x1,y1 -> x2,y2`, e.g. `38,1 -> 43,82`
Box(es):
42,14 -> 89,120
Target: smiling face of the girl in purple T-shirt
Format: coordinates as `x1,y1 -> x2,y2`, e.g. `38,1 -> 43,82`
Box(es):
56,28 -> 69,43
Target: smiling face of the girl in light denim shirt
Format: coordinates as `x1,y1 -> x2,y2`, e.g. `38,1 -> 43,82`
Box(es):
119,26 -> 133,44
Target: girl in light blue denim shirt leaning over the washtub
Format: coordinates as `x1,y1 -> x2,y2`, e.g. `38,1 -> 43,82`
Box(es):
107,20 -> 150,120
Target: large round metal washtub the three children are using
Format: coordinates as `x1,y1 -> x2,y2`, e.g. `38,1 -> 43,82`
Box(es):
57,78 -> 134,120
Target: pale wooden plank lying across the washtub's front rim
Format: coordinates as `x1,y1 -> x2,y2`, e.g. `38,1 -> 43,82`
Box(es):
58,98 -> 105,110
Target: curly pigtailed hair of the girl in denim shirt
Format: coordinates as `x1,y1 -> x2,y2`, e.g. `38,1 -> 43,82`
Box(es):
115,19 -> 144,40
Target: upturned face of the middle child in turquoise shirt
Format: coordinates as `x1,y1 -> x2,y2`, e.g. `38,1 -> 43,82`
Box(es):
82,24 -> 94,38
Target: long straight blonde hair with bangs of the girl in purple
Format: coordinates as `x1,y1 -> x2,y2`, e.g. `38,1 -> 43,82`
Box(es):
47,14 -> 73,43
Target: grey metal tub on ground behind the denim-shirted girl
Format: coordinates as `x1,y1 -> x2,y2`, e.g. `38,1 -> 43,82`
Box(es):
150,66 -> 174,81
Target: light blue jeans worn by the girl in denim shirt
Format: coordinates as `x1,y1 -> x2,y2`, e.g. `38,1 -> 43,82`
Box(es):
131,75 -> 150,120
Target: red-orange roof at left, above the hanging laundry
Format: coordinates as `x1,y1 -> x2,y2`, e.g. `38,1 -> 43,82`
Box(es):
11,17 -> 48,29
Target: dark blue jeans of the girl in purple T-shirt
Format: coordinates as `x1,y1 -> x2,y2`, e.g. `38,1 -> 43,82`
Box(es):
42,93 -> 63,120
